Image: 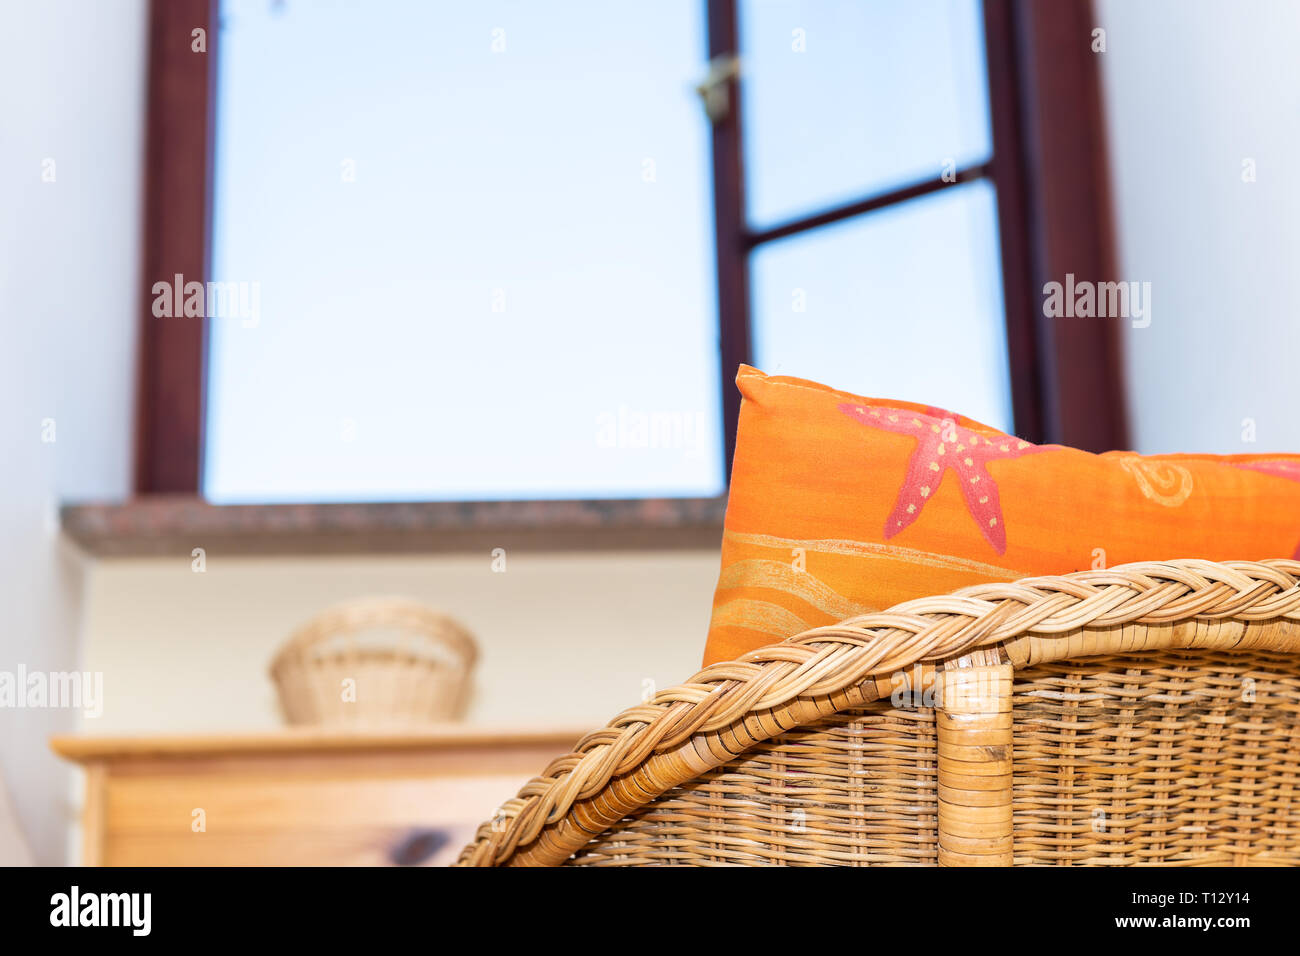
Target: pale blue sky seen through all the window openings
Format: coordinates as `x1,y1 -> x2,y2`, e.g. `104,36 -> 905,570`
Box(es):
204,0 -> 1011,503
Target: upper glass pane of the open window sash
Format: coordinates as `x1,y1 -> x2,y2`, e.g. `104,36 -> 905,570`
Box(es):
740,0 -> 992,225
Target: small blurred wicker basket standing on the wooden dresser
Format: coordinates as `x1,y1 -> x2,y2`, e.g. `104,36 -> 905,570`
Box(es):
270,597 -> 478,726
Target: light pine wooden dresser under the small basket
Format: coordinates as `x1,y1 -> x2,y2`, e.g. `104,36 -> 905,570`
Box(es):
51,724 -> 581,866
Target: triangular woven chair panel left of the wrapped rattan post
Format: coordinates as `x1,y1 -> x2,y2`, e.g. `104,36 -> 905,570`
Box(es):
571,704 -> 937,866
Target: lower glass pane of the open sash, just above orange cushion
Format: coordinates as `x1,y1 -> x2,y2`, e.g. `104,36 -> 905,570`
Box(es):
753,181 -> 1013,431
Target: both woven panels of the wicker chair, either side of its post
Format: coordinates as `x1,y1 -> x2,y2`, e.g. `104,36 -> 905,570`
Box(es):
569,650 -> 1300,866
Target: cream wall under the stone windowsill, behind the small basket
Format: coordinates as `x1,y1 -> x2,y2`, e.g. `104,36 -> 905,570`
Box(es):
83,549 -> 719,734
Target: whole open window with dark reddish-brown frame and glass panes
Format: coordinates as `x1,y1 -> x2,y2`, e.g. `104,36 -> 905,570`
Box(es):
138,0 -> 1122,512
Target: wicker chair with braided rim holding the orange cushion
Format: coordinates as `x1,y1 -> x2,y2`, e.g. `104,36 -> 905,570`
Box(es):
459,561 -> 1300,866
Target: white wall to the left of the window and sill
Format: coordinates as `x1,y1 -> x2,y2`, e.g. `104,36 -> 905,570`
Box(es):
0,0 -> 144,864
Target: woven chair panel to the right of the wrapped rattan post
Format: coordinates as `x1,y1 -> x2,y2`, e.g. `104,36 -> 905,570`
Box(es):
1013,652 -> 1300,866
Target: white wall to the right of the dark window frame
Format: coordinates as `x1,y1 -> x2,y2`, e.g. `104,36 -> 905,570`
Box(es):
1096,0 -> 1300,453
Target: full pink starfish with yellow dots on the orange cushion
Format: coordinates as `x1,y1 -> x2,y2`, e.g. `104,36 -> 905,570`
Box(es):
840,402 -> 1043,554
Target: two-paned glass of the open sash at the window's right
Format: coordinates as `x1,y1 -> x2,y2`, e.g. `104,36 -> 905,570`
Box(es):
738,0 -> 1013,431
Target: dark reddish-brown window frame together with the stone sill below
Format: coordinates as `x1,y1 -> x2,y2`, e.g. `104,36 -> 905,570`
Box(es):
94,0 -> 1126,550
